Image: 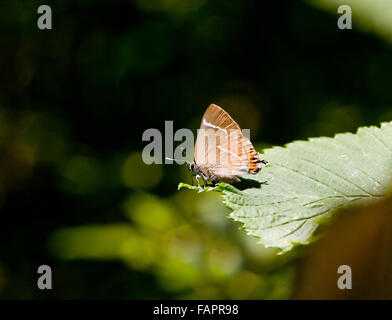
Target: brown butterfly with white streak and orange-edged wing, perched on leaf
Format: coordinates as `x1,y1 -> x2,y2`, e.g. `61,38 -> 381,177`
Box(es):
188,104 -> 268,188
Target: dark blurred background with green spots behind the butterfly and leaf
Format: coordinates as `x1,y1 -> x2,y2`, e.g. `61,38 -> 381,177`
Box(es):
0,0 -> 392,299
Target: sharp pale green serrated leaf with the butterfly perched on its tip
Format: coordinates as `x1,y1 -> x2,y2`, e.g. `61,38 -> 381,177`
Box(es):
179,122 -> 392,252
